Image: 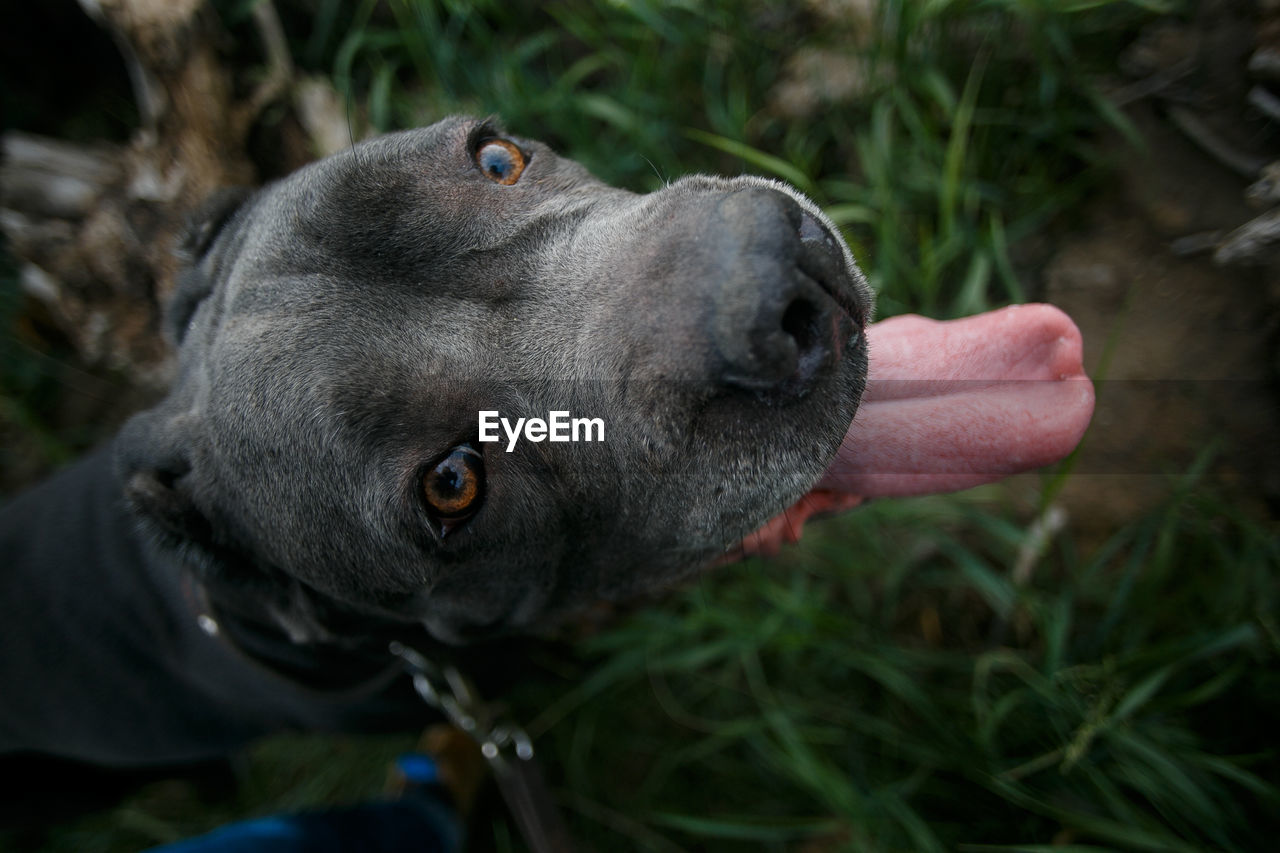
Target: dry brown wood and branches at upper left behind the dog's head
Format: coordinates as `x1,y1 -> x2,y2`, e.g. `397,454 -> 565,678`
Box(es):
0,0 -> 292,384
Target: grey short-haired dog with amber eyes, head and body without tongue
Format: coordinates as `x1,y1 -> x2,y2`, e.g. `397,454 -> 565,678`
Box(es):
0,118 -> 872,766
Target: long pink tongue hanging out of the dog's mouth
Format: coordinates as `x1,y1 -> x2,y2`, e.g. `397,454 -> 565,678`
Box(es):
742,305 -> 1093,553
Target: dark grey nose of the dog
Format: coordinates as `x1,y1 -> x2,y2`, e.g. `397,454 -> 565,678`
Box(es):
709,188 -> 844,394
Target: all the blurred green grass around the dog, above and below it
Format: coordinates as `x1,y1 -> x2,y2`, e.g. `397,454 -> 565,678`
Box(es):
0,0 -> 1280,852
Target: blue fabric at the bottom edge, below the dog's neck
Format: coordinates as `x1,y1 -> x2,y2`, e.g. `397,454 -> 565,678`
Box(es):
151,790 -> 462,853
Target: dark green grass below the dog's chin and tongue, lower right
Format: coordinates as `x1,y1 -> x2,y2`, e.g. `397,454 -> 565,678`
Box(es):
509,468 -> 1280,850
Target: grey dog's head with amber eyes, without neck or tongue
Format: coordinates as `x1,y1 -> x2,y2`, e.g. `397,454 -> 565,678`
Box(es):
120,119 -> 872,642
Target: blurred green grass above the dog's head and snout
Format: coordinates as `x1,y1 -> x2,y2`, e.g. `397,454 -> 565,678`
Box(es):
300,0 -> 1171,316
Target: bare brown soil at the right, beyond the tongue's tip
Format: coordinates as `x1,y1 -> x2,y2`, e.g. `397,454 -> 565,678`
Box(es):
1041,105 -> 1280,533
